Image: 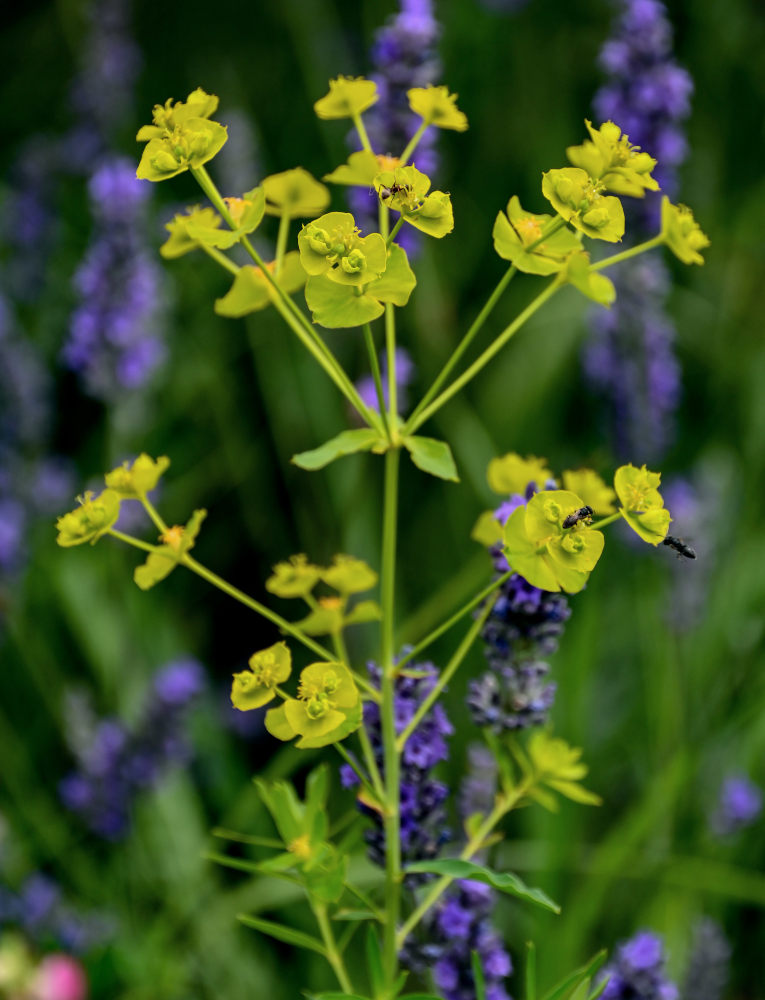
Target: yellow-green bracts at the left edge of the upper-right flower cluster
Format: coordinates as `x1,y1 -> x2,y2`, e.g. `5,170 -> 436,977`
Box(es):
492,195 -> 580,274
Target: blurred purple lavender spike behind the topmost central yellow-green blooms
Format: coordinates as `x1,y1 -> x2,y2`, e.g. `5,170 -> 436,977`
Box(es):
349,0 -> 441,255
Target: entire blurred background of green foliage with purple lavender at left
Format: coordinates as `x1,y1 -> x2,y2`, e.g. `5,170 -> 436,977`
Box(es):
0,0 -> 765,1000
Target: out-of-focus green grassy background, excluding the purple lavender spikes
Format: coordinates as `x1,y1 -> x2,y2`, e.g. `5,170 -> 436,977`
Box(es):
0,0 -> 765,1000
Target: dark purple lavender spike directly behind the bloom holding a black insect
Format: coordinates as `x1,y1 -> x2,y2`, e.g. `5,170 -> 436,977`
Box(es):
468,483 -> 571,732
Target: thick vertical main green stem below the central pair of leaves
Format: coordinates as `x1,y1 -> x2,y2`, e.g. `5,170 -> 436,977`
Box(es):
380,448 -> 401,988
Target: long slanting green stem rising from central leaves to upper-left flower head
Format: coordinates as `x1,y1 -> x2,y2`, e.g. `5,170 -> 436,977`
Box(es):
191,167 -> 382,430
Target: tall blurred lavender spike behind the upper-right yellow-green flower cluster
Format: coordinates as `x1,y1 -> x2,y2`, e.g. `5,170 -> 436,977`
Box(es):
584,0 -> 693,461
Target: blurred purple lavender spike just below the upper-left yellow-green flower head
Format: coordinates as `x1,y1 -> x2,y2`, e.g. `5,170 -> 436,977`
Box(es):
62,158 -> 165,401
